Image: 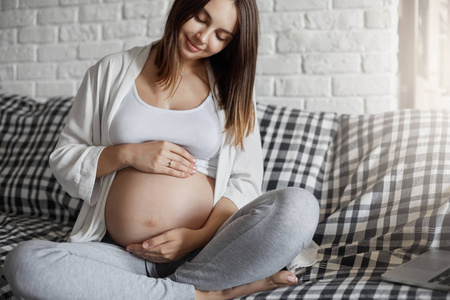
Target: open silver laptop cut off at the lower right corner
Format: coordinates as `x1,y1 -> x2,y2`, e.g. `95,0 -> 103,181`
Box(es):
381,249 -> 450,291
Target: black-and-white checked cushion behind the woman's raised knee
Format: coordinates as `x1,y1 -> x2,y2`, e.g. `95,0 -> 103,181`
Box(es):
257,103 -> 339,199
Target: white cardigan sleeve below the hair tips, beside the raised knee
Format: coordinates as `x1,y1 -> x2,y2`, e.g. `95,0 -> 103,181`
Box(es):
223,105 -> 263,209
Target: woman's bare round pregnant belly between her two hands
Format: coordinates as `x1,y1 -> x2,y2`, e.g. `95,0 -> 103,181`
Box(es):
105,168 -> 214,247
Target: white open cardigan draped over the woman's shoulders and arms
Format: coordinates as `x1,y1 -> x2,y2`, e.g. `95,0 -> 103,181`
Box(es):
50,44 -> 263,242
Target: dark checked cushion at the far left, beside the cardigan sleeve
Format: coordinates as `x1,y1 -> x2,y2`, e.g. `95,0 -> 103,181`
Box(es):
0,94 -> 81,223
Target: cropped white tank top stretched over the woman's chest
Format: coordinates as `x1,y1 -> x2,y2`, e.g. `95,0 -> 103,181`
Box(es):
109,84 -> 222,178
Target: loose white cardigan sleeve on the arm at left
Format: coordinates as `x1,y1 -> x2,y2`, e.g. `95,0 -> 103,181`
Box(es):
50,64 -> 105,205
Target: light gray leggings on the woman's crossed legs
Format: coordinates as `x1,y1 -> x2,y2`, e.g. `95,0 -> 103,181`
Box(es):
4,188 -> 319,299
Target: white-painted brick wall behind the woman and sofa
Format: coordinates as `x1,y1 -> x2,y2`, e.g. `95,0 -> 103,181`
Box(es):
0,0 -> 398,113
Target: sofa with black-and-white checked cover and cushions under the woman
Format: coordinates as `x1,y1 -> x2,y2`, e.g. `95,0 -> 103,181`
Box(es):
0,93 -> 450,299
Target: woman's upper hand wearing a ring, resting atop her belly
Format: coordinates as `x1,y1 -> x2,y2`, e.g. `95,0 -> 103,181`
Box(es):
128,141 -> 197,178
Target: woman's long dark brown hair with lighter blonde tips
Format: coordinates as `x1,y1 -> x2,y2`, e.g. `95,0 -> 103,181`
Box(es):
155,0 -> 259,148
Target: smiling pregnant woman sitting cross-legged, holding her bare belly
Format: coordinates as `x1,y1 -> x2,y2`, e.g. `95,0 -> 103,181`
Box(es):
4,0 -> 318,299
